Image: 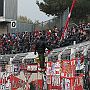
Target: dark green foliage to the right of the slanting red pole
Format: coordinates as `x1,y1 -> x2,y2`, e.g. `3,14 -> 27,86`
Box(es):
72,0 -> 90,21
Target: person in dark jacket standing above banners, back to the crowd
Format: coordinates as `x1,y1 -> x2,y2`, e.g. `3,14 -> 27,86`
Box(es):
34,35 -> 51,69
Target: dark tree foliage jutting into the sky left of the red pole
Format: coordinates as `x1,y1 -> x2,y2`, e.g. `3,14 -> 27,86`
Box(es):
37,0 -> 67,16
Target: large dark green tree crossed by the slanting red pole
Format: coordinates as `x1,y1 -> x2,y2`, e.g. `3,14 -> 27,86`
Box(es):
37,0 -> 90,20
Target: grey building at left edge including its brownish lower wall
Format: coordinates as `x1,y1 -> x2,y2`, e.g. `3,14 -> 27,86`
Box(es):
0,0 -> 17,34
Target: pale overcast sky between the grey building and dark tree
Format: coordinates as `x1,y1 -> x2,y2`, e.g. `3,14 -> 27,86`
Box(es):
18,0 -> 52,22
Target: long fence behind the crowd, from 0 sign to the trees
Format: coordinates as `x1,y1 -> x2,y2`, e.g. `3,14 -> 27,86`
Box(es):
8,8 -> 69,33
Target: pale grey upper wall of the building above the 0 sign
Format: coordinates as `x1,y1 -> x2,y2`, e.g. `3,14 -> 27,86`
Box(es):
0,0 -> 17,22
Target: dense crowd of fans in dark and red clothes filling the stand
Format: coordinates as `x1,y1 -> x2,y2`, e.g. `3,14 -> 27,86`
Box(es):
0,24 -> 90,54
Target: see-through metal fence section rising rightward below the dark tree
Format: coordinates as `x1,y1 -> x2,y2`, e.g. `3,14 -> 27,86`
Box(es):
35,8 -> 69,30
